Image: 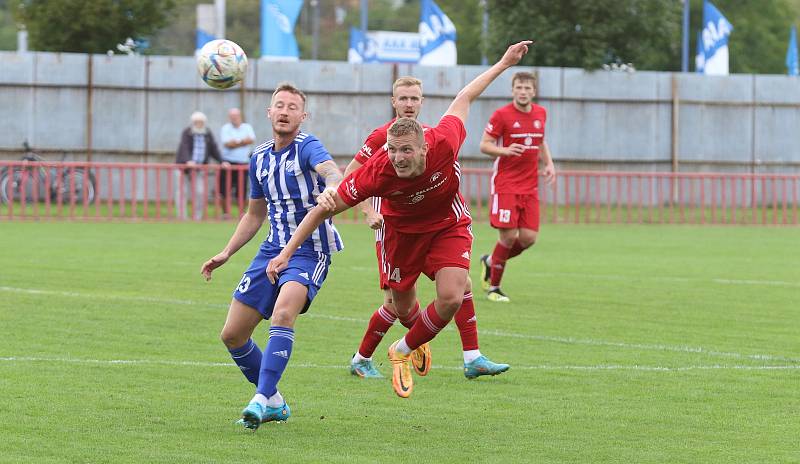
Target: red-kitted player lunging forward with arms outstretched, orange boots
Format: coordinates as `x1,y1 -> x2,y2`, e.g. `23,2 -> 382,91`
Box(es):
267,41 -> 532,398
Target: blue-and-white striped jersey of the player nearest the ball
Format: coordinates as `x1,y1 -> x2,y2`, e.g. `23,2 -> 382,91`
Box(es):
250,132 -> 344,256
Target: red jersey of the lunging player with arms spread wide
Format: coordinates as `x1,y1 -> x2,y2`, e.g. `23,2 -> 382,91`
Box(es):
338,115 -> 471,234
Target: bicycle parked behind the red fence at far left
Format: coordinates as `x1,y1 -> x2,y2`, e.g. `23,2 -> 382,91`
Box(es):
0,141 -> 97,204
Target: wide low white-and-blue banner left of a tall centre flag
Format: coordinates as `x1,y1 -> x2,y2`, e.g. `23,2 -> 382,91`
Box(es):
347,27 -> 420,63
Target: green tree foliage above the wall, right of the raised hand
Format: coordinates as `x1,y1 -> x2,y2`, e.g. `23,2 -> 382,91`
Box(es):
488,0 -> 681,70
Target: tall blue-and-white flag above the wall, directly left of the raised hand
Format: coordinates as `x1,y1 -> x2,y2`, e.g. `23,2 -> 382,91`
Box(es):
419,0 -> 457,66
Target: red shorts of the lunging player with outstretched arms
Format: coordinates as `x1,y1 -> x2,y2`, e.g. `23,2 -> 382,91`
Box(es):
379,222 -> 472,291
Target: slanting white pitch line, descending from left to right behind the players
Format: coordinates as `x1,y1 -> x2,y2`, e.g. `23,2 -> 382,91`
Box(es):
0,286 -> 800,363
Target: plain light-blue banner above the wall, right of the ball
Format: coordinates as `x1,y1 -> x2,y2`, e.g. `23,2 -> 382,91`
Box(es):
261,0 -> 303,61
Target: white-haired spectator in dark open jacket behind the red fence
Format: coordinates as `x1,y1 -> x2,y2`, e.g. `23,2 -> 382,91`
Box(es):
174,111 -> 222,221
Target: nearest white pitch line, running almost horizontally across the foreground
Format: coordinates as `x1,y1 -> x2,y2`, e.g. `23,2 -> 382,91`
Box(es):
0,356 -> 800,372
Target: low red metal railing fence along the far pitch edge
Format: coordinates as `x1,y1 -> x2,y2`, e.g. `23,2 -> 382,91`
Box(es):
0,161 -> 800,225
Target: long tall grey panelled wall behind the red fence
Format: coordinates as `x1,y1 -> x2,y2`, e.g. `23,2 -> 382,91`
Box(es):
0,52 -> 800,173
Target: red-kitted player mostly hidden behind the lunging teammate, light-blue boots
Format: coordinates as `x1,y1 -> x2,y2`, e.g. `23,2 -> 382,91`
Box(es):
345,76 -> 508,379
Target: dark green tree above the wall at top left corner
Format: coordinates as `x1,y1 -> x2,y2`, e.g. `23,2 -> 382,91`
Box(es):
12,0 -> 174,53
